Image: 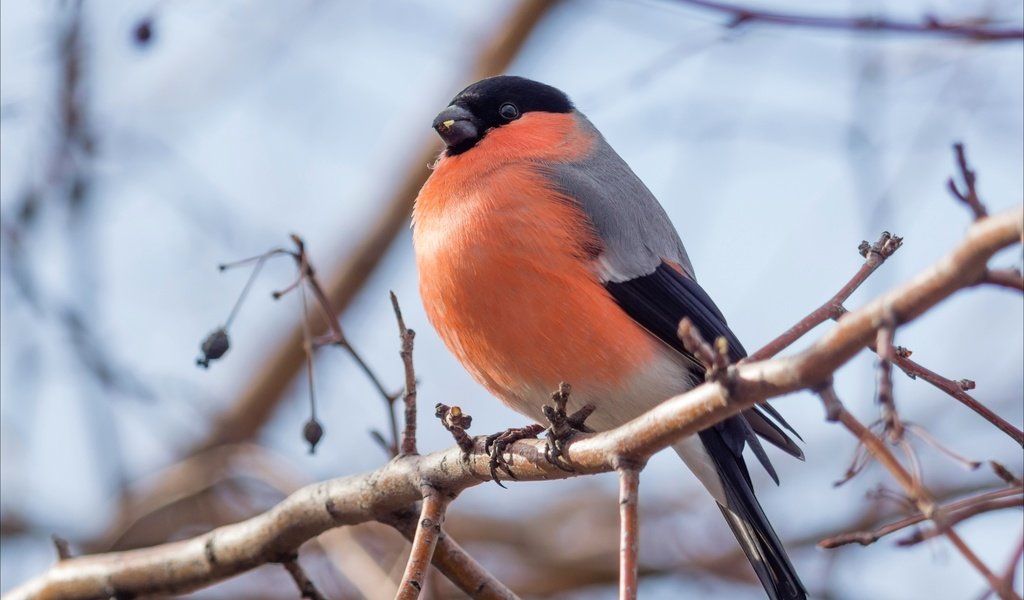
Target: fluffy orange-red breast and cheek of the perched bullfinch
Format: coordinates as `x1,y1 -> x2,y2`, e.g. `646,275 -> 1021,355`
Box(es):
414,115 -> 657,410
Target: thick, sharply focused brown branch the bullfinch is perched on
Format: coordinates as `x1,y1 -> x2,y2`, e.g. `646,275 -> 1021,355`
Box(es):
8,206 -> 1024,600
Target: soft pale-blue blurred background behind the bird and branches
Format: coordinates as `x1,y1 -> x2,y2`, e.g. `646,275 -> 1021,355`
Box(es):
0,0 -> 1024,599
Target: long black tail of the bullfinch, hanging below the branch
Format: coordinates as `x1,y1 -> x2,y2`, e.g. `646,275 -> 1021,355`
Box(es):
699,427 -> 807,600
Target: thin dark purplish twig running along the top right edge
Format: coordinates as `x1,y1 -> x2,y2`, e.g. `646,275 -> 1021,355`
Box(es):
679,0 -> 1024,42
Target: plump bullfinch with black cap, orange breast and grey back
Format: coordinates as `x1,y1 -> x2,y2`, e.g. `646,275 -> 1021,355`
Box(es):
412,75 -> 807,600
